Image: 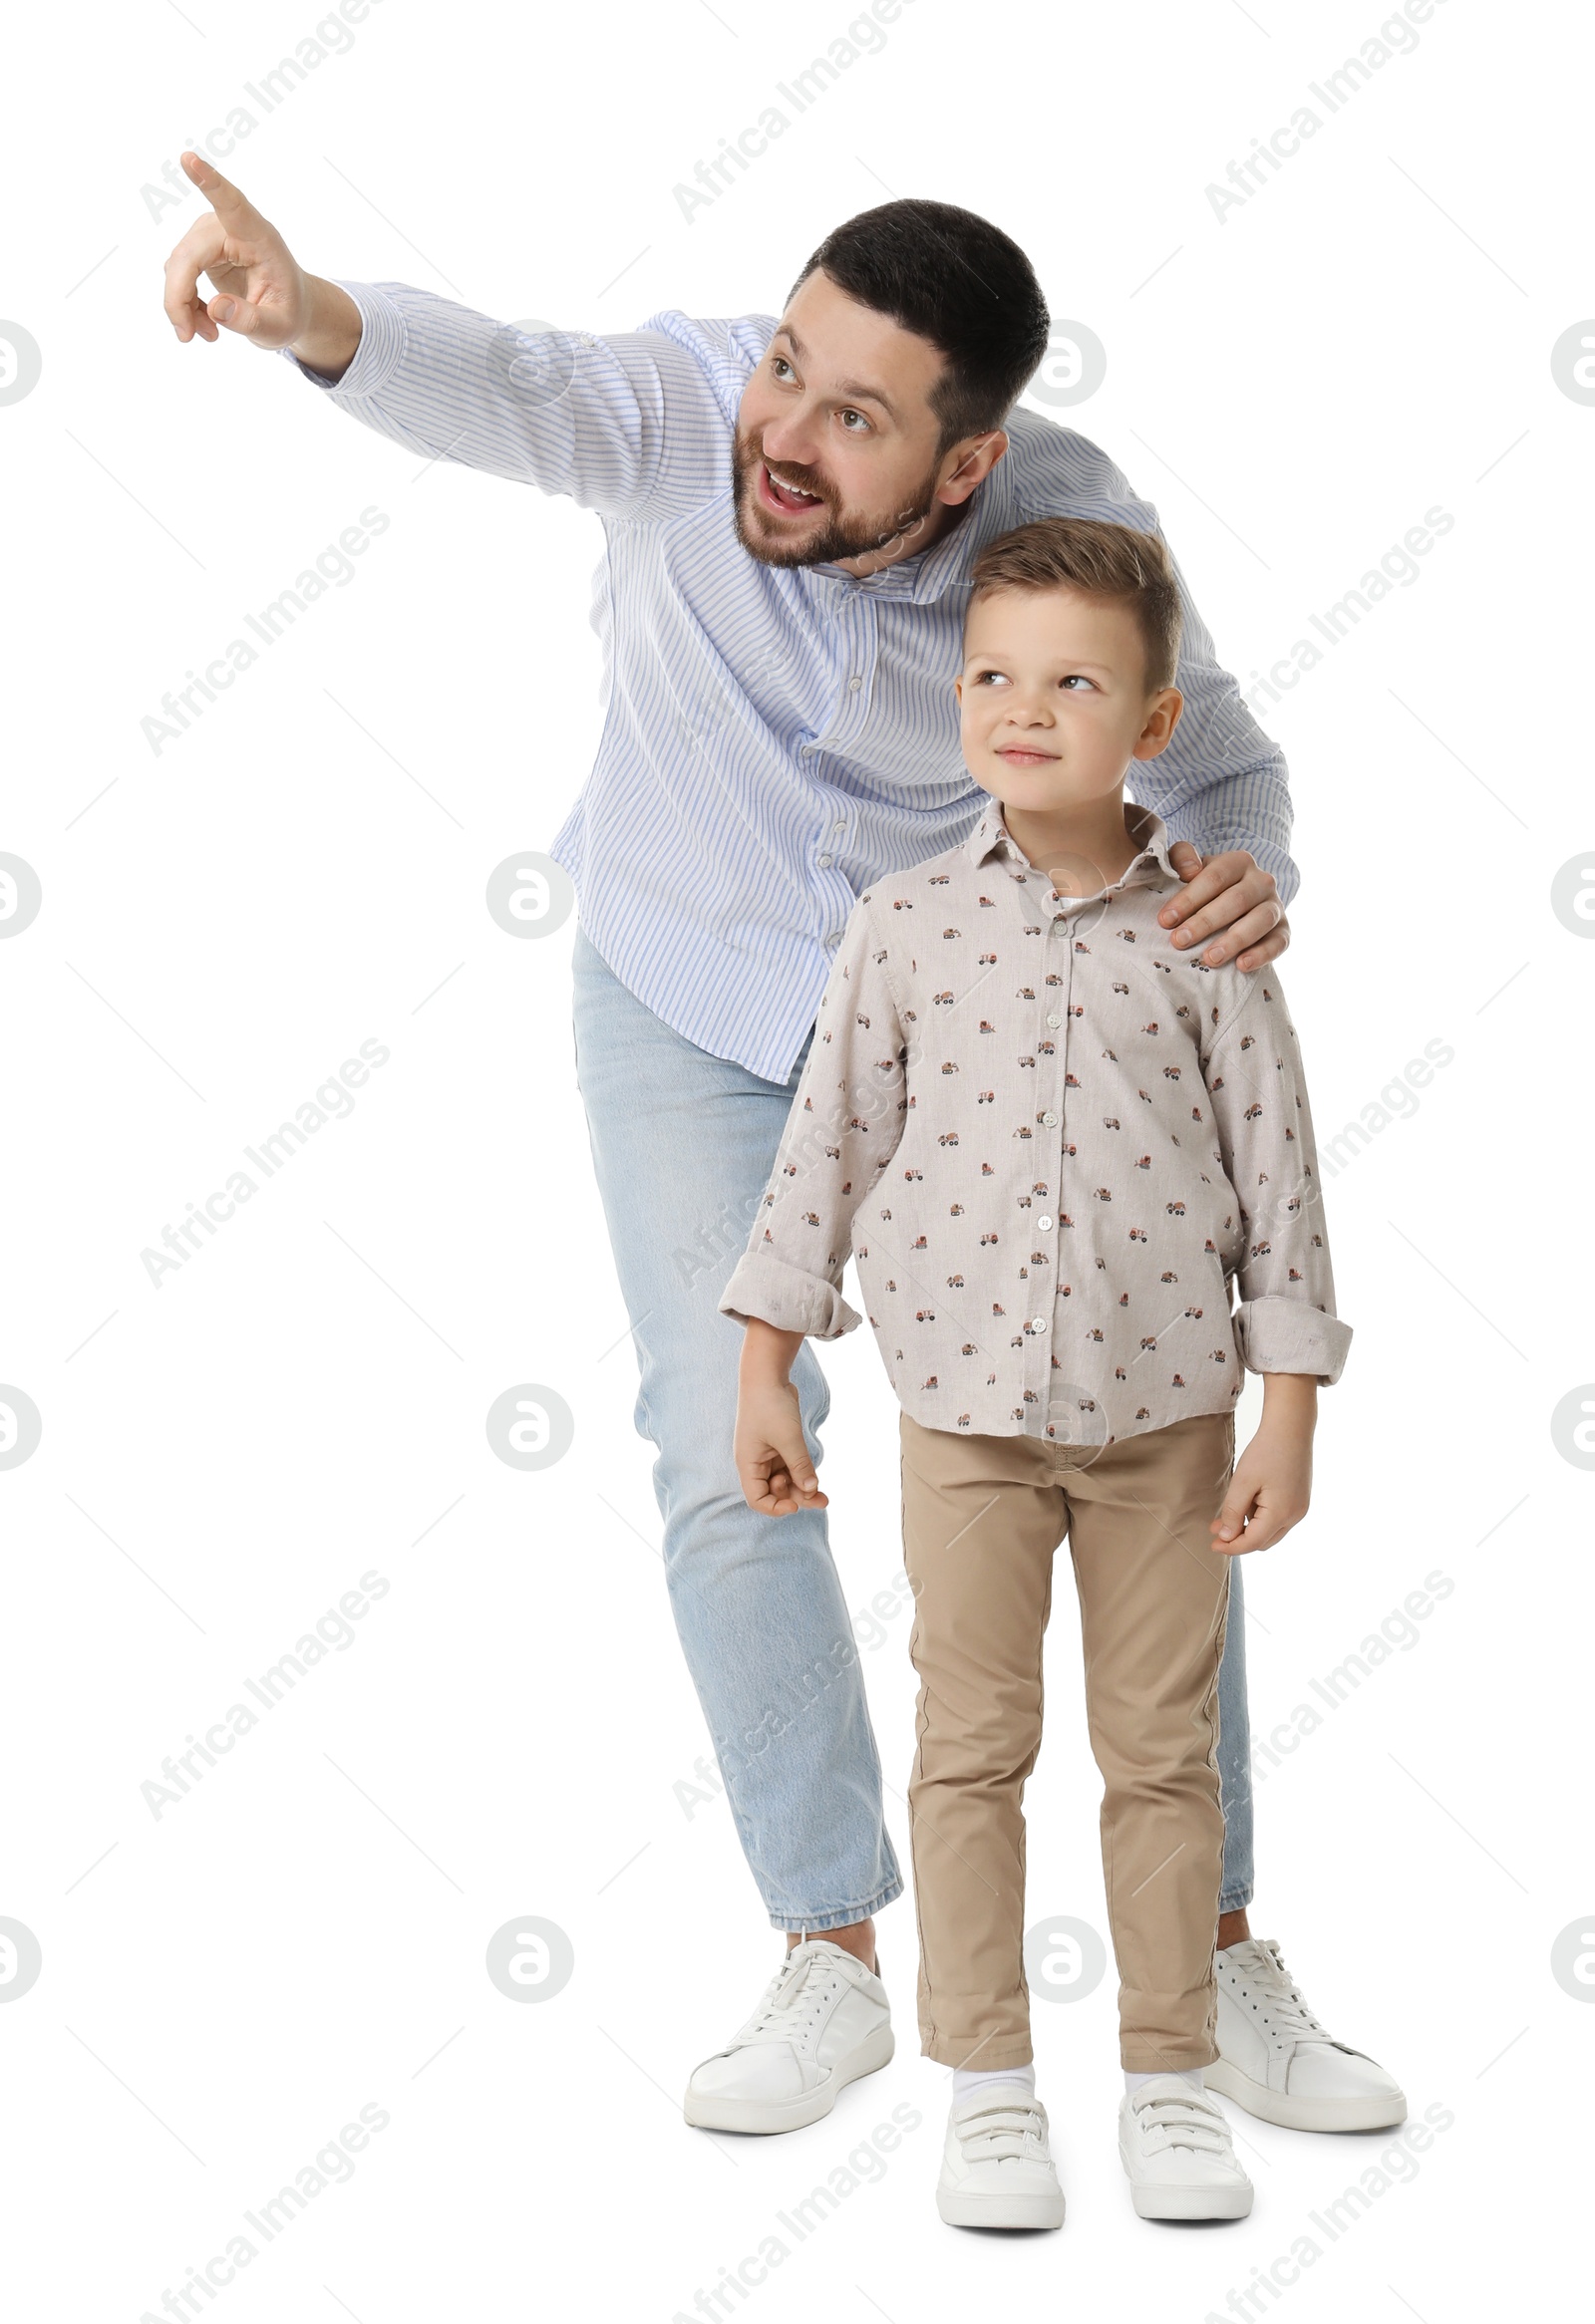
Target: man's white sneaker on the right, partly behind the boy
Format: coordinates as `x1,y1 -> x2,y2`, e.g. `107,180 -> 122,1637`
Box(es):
1204,1936 -> 1407,2131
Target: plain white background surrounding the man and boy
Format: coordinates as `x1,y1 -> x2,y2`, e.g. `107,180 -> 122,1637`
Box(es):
0,0 -> 1595,2324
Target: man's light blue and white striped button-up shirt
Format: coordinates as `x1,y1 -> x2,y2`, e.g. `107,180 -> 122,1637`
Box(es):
288,284 -> 1297,1080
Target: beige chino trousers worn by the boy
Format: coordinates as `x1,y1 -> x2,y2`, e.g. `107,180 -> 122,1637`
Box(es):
900,1411 -> 1234,2073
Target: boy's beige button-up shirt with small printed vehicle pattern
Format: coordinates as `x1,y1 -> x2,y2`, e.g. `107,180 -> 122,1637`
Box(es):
719,799 -> 1351,1443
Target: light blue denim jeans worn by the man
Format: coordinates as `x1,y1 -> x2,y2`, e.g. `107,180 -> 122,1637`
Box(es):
572,927 -> 1251,1929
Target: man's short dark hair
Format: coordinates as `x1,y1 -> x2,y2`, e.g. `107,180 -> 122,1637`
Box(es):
786,202 -> 1049,460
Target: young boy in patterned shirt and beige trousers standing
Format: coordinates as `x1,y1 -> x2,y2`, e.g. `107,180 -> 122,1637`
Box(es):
721,518 -> 1351,2226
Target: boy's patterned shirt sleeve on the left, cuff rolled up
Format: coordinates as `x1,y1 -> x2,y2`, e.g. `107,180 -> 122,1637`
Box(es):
719,895 -> 907,1338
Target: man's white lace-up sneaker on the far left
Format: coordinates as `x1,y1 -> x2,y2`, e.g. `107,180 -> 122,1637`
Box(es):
684,1936 -> 893,2131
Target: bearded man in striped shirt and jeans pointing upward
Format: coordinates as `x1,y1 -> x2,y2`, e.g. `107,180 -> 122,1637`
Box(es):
165,153 -> 1405,2131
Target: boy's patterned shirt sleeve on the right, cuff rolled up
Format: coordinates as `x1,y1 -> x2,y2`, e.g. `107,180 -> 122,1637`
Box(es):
1204,967 -> 1351,1387
